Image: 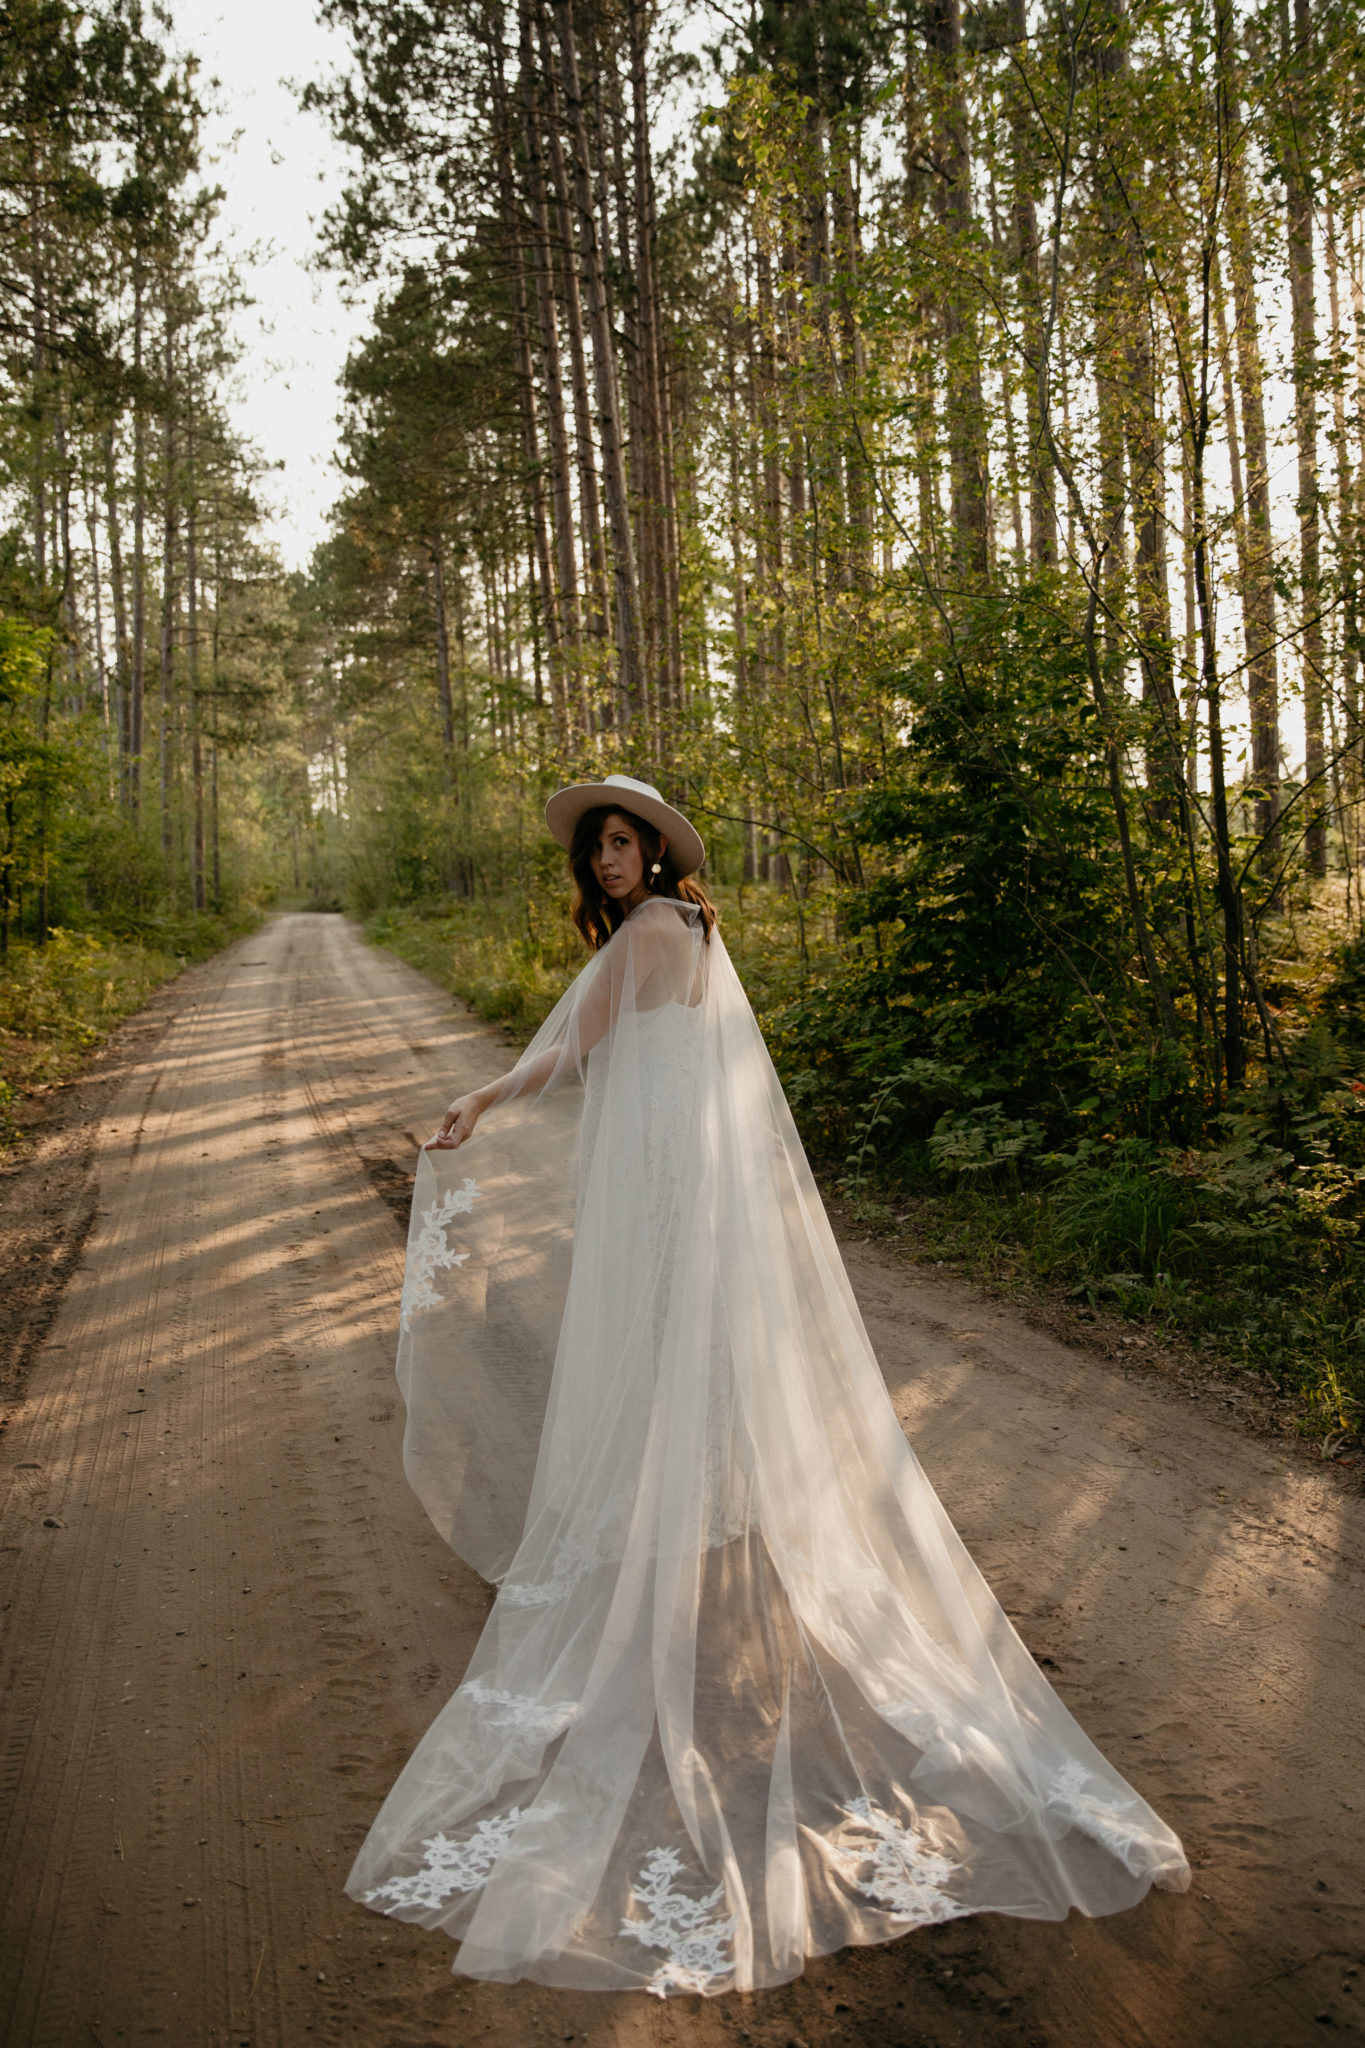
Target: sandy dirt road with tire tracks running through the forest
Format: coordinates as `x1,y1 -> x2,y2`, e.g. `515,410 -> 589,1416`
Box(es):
0,915 -> 1365,2048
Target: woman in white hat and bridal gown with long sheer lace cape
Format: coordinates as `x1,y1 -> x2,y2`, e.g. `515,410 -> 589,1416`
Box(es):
348,776 -> 1189,1997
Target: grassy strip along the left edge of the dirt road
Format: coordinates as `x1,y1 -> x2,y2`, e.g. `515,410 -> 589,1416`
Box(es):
0,911 -> 258,1155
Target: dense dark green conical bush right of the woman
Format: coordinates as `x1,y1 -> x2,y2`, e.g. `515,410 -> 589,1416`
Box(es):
772,590 -> 1203,1174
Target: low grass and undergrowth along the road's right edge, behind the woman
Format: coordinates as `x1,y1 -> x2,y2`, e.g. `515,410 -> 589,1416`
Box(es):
364,885 -> 1365,1458
